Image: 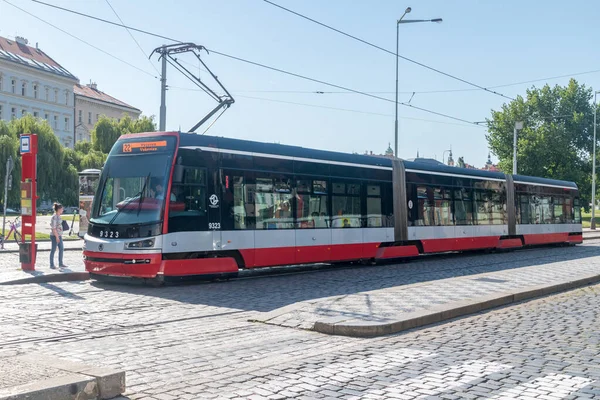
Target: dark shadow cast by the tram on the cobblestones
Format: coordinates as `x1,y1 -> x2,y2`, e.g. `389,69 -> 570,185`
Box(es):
92,246 -> 600,312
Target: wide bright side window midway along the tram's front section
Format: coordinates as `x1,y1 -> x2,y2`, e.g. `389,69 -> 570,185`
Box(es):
254,178 -> 294,229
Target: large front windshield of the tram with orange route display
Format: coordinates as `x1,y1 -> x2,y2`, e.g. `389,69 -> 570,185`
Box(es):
90,138 -> 174,225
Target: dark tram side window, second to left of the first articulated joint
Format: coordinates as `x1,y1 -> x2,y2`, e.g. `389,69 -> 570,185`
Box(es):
331,182 -> 361,228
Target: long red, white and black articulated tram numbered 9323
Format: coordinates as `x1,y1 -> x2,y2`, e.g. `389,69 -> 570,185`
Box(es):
84,132 -> 582,282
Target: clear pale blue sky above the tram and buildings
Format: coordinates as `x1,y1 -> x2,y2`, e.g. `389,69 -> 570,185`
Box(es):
0,0 -> 600,167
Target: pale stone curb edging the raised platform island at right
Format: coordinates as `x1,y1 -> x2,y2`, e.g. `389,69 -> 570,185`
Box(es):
313,274 -> 600,337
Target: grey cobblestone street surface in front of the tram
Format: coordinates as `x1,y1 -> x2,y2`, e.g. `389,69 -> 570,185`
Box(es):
0,241 -> 600,400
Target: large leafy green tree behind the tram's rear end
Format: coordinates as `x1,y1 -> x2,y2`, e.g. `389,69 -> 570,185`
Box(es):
486,79 -> 594,206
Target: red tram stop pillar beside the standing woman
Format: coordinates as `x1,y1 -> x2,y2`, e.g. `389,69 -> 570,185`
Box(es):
20,134 -> 37,271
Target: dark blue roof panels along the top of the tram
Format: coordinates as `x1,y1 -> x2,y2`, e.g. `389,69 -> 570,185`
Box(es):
173,133 -> 577,189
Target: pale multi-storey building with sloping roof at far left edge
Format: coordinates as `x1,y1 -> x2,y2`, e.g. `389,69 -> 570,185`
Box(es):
0,37 -> 79,148
